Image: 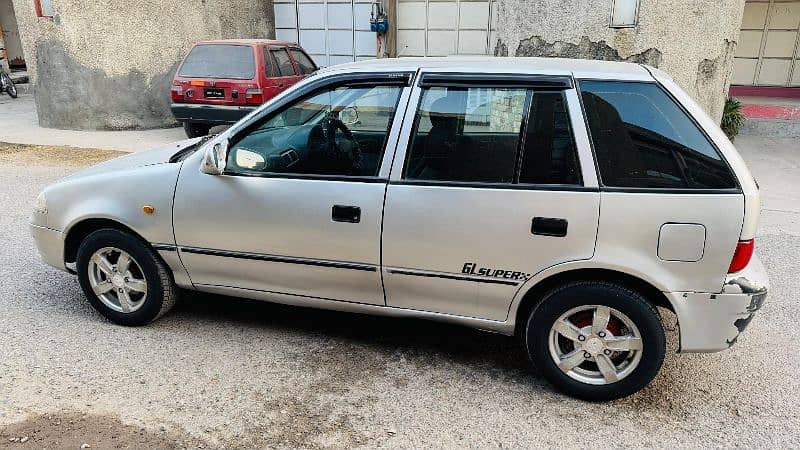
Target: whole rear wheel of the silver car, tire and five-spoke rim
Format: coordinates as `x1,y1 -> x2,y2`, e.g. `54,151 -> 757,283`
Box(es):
525,282 -> 666,401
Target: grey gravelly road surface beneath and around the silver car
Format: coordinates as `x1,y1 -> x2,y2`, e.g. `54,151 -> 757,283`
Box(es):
0,144 -> 800,448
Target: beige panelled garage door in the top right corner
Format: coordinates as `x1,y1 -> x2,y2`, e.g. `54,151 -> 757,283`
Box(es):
731,0 -> 800,86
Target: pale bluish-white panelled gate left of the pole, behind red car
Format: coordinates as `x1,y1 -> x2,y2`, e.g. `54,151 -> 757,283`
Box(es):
273,0 -> 375,66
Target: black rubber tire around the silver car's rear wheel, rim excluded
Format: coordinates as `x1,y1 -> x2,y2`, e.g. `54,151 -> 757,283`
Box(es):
525,281 -> 667,401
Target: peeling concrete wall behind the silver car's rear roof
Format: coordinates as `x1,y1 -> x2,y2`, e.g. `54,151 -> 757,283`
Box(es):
495,0 -> 745,119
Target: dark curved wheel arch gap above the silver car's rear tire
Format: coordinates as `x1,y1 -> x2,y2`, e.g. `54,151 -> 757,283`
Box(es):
512,267 -> 675,335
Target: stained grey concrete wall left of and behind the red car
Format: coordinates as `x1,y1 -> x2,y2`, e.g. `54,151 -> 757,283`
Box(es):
13,0 -> 275,129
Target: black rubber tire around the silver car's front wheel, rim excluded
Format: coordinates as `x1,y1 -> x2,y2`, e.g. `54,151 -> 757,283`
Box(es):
76,229 -> 179,326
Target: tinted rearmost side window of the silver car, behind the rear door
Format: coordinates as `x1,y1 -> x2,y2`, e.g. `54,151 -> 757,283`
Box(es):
580,81 -> 736,189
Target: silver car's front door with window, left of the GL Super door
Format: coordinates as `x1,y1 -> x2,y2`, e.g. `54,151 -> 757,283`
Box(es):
174,74 -> 410,305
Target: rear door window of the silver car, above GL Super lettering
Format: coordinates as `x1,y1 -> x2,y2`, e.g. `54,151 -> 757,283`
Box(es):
404,87 -> 581,185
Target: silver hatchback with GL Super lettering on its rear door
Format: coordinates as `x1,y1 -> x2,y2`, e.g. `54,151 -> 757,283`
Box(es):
31,58 -> 768,400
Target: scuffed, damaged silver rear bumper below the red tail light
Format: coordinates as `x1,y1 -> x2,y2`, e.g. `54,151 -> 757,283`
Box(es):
667,256 -> 769,353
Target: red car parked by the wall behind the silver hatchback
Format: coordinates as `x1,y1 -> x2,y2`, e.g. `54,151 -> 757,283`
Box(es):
171,39 -> 317,137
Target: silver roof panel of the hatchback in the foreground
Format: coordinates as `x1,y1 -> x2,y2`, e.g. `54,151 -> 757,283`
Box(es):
321,56 -> 664,81
